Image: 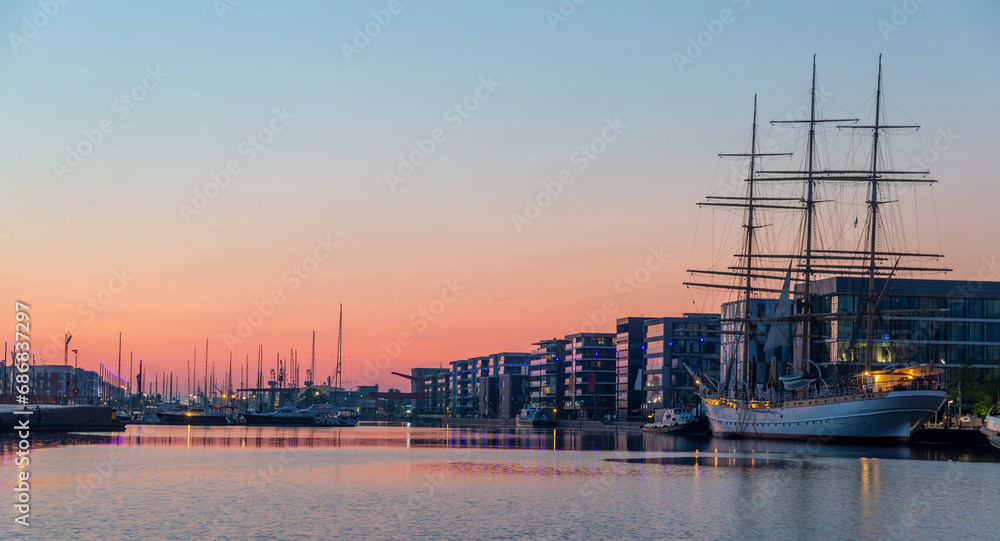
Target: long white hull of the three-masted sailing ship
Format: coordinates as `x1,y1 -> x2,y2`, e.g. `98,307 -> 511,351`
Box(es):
705,390 -> 948,442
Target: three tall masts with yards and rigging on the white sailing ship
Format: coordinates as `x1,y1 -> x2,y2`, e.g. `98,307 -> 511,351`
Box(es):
684,55 -> 951,385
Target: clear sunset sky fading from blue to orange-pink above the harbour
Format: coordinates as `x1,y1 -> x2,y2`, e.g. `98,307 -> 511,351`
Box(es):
0,0 -> 1000,388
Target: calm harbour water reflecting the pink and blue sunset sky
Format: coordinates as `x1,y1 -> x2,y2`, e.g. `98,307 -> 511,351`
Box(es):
0,426 -> 1000,540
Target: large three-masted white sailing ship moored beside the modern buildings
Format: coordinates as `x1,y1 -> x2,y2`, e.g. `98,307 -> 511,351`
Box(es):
685,56 -> 950,441
